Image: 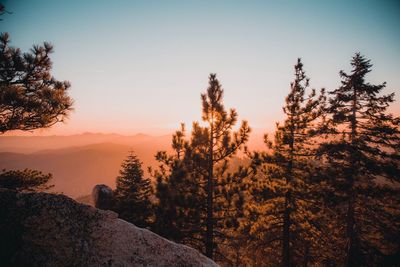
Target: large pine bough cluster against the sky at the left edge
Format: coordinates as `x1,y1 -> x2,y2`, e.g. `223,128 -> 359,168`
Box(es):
0,33 -> 73,133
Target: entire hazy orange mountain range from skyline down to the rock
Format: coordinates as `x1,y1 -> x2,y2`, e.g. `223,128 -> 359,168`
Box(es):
0,133 -> 171,198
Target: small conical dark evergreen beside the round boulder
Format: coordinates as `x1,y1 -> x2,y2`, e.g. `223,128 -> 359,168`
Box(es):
115,152 -> 152,227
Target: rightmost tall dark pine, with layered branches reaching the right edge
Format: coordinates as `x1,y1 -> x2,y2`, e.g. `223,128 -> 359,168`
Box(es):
320,53 -> 400,266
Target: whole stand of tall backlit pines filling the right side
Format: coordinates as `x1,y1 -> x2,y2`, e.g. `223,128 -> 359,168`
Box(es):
153,59 -> 400,266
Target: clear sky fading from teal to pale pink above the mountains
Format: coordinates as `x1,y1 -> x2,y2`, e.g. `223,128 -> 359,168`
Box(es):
0,0 -> 400,135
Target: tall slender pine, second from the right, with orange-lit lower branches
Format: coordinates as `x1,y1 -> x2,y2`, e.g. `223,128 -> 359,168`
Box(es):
248,59 -> 327,266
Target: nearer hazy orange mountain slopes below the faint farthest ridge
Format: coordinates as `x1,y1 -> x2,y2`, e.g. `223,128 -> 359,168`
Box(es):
0,139 -> 170,198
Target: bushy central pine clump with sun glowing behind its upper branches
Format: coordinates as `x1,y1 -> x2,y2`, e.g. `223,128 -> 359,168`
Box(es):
152,74 -> 250,258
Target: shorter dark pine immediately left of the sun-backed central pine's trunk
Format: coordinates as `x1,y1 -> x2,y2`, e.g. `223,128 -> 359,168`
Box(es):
153,124 -> 206,250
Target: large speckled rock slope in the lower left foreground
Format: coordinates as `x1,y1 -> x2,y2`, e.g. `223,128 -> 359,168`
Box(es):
0,189 -> 217,267
